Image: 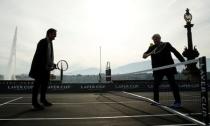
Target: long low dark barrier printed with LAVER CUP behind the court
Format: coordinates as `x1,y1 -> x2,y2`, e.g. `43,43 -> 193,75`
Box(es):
0,80 -> 210,93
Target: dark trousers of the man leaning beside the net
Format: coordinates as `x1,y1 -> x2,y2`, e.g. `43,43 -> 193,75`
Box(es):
153,74 -> 181,103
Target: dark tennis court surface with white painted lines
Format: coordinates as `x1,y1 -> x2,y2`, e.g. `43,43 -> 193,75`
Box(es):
0,92 -> 208,126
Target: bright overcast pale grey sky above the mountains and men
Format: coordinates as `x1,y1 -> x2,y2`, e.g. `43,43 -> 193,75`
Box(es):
0,0 -> 210,74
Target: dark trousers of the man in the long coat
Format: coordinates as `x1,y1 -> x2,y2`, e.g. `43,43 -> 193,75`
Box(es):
32,79 -> 49,105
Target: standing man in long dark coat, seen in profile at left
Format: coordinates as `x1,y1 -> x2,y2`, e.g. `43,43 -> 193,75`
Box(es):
29,28 -> 56,110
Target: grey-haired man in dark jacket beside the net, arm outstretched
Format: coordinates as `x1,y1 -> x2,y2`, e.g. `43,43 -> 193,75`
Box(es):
143,34 -> 185,108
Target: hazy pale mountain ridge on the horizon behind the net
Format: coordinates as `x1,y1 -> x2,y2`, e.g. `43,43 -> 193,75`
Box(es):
67,58 -> 210,75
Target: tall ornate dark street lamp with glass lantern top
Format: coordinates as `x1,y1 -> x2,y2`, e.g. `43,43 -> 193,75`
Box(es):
182,8 -> 199,80
